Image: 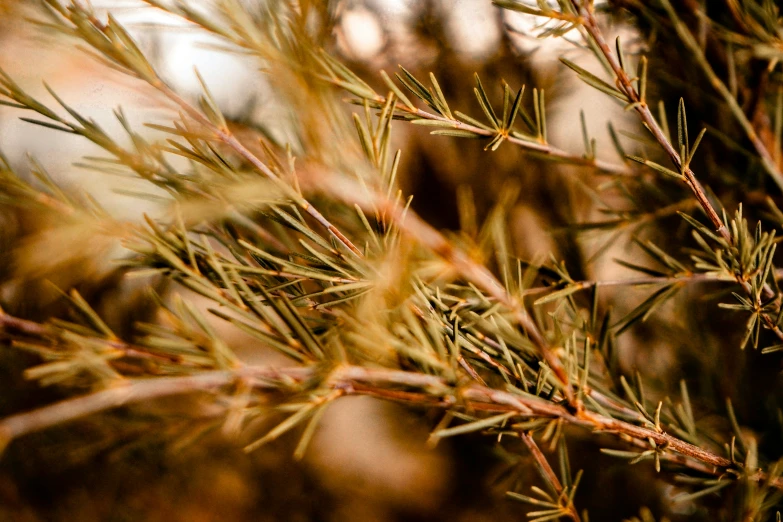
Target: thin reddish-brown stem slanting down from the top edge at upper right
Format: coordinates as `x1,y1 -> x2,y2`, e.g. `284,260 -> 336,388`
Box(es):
571,0 -> 783,340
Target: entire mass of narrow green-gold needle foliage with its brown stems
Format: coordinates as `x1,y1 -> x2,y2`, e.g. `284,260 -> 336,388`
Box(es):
0,0 -> 783,522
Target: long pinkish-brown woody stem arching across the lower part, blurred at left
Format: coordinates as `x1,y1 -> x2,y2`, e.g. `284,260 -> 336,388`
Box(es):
0,358 -> 783,490
